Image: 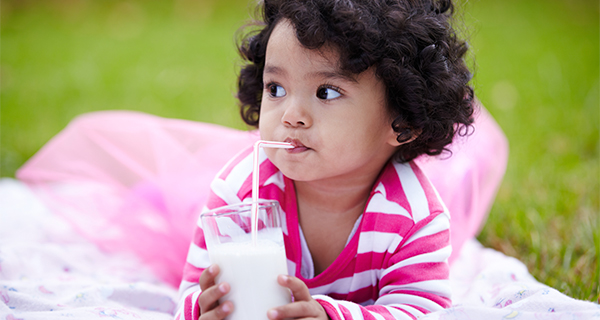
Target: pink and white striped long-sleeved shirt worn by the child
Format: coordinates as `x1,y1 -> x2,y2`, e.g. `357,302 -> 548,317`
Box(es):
175,148 -> 451,320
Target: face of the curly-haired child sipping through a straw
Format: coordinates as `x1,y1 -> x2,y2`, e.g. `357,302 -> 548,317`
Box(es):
259,20 -> 399,181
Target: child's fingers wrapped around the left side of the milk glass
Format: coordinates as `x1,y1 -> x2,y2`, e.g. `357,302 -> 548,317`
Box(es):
198,264 -> 233,320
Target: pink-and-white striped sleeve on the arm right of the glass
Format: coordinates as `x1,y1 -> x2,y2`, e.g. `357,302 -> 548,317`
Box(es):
313,212 -> 452,320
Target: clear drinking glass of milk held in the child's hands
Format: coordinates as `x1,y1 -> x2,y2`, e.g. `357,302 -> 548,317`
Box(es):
201,200 -> 291,320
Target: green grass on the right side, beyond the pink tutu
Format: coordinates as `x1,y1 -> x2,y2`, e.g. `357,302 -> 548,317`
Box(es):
465,0 -> 600,301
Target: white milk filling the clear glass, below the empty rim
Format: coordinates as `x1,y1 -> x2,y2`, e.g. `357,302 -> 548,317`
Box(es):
209,236 -> 291,320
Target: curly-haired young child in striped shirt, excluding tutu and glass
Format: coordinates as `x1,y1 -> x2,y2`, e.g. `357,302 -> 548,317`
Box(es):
176,0 -> 474,319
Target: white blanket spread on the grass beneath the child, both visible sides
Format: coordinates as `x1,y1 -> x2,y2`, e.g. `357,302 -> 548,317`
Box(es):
0,179 -> 600,320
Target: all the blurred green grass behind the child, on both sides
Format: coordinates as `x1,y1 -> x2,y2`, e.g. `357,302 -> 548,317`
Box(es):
0,0 -> 600,301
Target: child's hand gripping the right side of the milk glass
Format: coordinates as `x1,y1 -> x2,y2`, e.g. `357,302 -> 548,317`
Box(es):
267,275 -> 329,320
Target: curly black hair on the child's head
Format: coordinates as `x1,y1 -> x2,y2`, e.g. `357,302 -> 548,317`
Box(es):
237,0 -> 474,162
